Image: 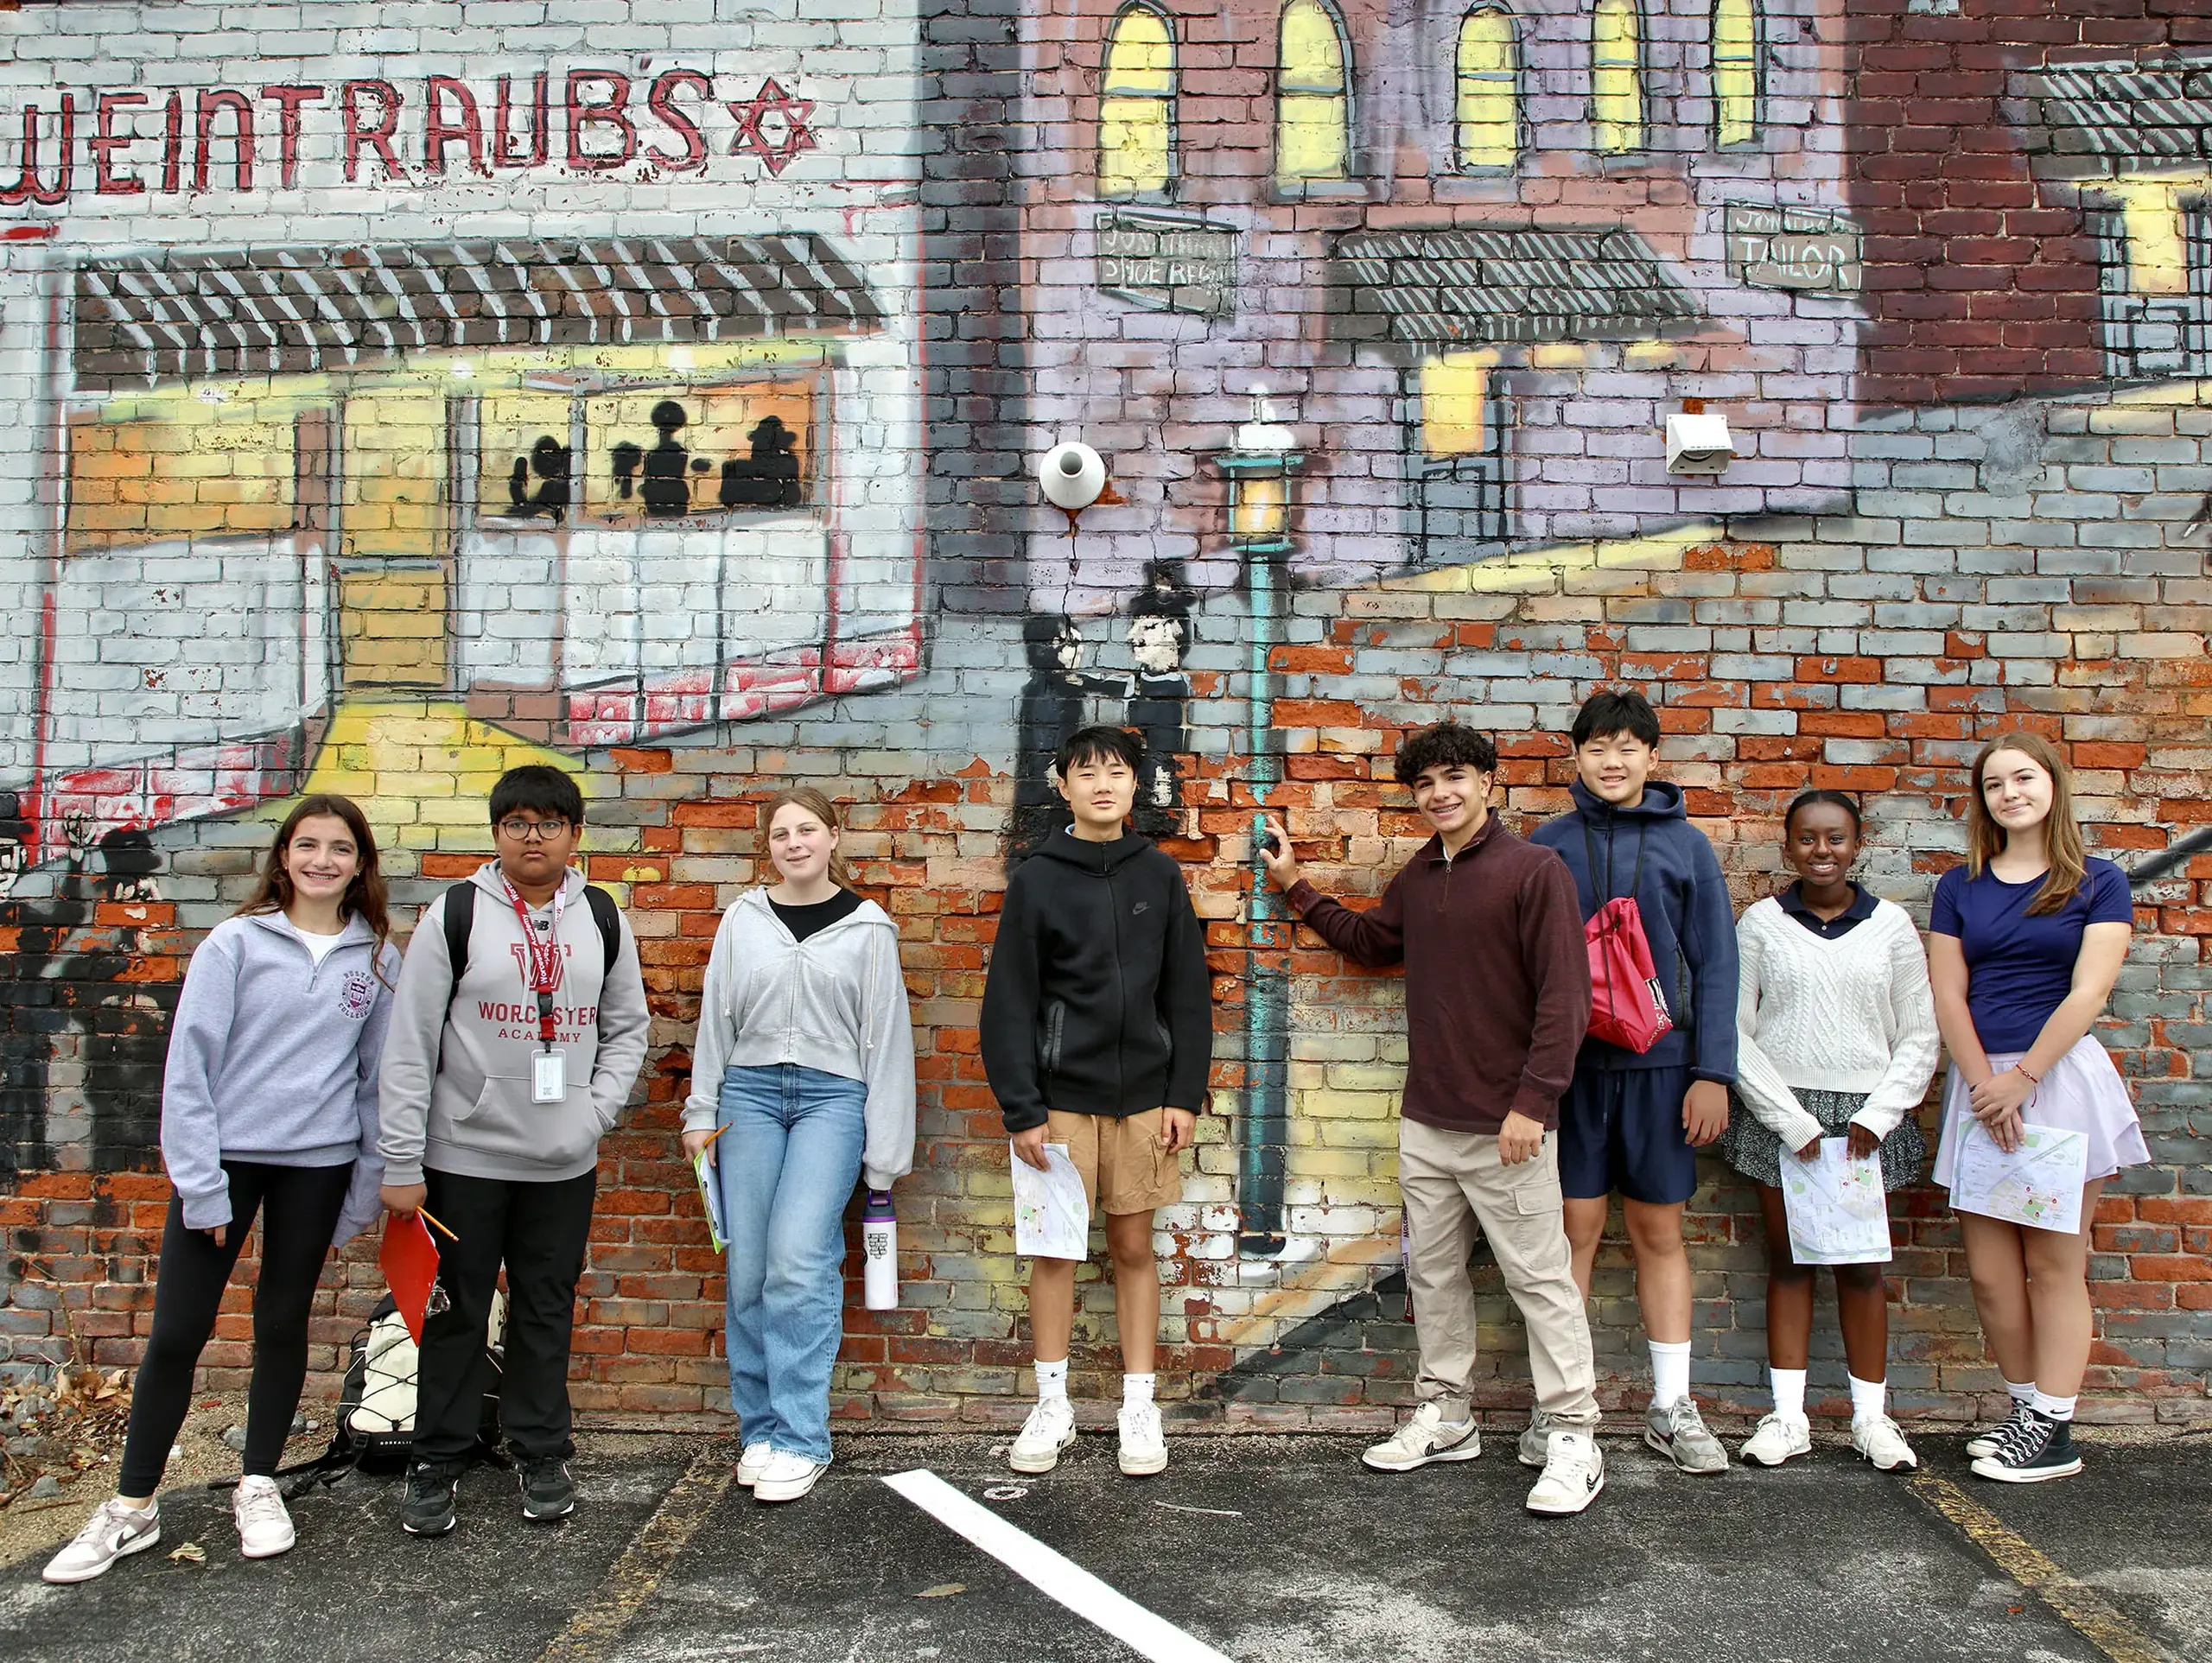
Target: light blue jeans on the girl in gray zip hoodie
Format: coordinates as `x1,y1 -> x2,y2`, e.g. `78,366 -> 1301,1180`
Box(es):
715,1063 -> 868,1462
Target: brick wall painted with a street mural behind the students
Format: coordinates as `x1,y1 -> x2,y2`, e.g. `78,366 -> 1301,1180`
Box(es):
0,0 -> 2212,1426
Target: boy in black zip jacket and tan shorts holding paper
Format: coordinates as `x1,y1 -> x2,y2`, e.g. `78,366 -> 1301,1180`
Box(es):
982,727 -> 1214,1475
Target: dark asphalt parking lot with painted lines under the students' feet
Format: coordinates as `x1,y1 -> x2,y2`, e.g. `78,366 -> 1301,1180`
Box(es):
0,1435 -> 2212,1663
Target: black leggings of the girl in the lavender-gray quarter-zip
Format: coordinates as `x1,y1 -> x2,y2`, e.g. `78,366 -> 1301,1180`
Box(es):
115,1161 -> 354,1495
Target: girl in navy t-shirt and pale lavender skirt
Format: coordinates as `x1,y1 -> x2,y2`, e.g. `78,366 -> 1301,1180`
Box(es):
1929,732 -> 2150,1484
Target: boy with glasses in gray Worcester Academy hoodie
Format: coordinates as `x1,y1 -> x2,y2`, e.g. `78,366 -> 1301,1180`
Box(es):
380,765 -> 648,1535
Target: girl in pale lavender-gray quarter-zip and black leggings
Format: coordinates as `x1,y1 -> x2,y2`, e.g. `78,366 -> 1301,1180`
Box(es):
47,794 -> 400,1584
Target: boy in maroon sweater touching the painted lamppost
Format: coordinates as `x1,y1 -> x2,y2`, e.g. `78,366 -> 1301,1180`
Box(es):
1261,723 -> 1606,1513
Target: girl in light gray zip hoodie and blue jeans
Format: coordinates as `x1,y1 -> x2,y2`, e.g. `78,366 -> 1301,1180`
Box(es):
683,787 -> 913,1501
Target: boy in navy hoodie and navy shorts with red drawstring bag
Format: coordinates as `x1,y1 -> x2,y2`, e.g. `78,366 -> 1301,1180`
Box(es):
1529,692 -> 1737,1473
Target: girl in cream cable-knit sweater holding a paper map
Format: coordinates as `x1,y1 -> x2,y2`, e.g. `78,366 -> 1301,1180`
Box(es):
1721,791 -> 1938,1470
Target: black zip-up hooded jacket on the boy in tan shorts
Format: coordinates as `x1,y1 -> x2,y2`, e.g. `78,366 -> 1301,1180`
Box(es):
982,829 -> 1214,1133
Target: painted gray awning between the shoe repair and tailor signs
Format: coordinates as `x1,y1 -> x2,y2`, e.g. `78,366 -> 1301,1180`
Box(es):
1330,225 -> 1703,347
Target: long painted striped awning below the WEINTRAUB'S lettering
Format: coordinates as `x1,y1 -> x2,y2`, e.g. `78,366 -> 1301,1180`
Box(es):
71,234 -> 882,391
